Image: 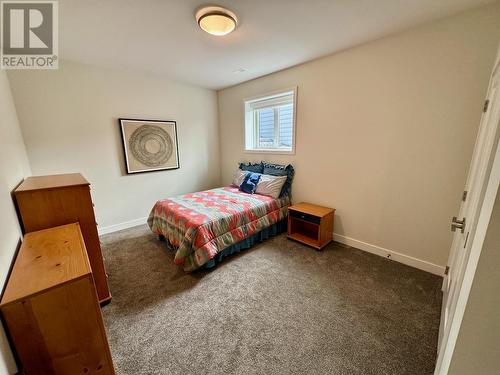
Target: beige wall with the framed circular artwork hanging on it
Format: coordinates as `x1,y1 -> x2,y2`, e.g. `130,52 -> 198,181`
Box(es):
9,61 -> 220,228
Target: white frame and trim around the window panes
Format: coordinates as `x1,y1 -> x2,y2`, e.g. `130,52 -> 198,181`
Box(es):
243,86 -> 297,155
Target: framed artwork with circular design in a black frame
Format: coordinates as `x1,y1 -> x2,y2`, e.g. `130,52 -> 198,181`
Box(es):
119,118 -> 179,174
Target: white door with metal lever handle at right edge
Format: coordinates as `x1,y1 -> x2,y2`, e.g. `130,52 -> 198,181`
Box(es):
437,54 -> 500,368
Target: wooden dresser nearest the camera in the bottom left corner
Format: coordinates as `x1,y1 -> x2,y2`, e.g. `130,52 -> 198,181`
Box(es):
0,223 -> 114,375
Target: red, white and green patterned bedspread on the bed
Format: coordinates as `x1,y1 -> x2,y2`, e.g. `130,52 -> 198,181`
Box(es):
148,187 -> 290,272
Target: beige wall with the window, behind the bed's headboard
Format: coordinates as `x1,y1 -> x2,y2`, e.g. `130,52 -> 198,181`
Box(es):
219,5 -> 500,269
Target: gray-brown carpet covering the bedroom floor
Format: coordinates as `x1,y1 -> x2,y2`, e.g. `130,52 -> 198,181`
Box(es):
102,226 -> 441,375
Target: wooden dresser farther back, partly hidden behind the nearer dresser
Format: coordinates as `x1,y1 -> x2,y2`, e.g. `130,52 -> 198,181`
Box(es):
14,173 -> 111,304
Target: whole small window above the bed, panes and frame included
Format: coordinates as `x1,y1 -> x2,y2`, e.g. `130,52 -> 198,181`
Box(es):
245,88 -> 297,153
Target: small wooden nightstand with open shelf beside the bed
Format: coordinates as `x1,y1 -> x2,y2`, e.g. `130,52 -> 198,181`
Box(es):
288,203 -> 335,250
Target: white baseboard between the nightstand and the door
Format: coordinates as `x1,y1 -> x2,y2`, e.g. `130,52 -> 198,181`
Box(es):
333,233 -> 445,276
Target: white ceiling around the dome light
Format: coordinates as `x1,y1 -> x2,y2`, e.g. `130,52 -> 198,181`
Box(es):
59,0 -> 495,89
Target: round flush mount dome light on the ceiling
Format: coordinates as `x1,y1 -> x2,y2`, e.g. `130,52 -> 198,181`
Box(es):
195,6 -> 238,36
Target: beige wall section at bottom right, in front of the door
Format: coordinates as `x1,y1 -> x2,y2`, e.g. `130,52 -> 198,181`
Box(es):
449,189 -> 500,375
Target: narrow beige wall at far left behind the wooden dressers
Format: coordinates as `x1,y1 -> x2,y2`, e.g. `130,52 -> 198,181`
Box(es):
0,70 -> 30,375
